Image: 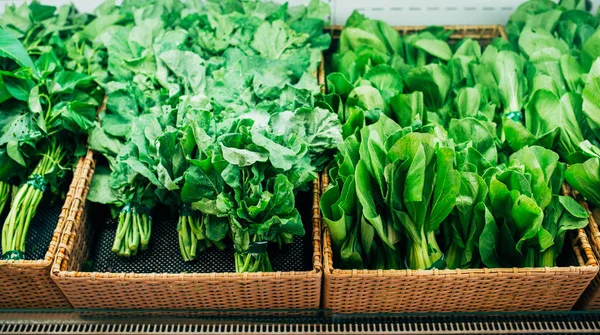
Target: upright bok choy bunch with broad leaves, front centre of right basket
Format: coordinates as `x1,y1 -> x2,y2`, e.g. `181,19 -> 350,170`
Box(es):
390,133 -> 460,269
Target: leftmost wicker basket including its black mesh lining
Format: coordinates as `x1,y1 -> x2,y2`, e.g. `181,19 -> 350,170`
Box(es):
0,160 -> 88,308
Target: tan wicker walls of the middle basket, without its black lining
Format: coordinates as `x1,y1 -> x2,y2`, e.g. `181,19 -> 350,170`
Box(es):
52,152 -> 322,309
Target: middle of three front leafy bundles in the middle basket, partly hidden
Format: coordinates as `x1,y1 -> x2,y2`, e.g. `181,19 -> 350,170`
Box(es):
157,100 -> 229,261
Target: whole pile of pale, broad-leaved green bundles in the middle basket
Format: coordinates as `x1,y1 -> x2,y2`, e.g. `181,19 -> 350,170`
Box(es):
86,0 -> 342,272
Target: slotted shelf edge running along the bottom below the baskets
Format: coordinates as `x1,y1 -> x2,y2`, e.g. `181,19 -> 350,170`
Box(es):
0,310 -> 600,334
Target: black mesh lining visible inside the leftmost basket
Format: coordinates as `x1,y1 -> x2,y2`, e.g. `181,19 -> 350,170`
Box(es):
0,200 -> 62,260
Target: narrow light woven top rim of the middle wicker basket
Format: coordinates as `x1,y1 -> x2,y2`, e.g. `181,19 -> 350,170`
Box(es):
50,59 -> 325,281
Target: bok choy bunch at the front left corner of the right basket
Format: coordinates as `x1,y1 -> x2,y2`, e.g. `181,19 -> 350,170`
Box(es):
321,116 -> 401,268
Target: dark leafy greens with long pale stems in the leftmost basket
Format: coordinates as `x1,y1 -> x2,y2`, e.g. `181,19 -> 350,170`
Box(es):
0,2 -> 104,259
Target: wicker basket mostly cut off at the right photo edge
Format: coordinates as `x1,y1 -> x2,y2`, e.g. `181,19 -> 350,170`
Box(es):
577,197 -> 600,310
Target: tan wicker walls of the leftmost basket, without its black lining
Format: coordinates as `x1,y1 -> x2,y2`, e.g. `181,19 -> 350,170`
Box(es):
0,156 -> 92,308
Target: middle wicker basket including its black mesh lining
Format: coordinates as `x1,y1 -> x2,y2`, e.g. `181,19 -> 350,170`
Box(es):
52,152 -> 322,309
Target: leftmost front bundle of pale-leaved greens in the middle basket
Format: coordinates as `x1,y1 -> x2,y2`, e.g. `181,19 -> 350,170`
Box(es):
88,114 -> 164,256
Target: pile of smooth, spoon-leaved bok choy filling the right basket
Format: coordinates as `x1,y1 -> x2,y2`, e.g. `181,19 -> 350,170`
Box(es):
321,0 -> 600,269
